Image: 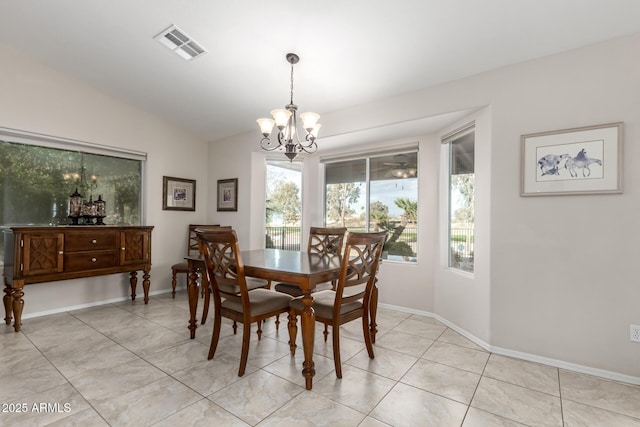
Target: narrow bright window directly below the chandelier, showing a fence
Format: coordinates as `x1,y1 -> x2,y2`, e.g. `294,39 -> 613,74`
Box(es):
265,160 -> 302,251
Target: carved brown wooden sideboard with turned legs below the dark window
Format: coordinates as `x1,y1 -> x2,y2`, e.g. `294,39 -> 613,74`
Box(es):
3,226 -> 153,332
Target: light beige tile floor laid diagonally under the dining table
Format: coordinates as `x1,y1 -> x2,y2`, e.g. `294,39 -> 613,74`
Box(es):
0,292 -> 640,427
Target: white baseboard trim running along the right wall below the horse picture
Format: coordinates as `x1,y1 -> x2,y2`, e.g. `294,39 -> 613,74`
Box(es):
379,304 -> 640,385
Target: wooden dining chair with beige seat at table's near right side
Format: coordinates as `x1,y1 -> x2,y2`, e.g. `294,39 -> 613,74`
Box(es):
289,231 -> 387,378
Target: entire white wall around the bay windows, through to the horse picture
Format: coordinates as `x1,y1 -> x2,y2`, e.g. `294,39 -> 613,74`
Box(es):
209,35 -> 640,383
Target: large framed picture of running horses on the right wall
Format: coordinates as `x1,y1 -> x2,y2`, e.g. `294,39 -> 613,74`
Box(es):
520,122 -> 624,196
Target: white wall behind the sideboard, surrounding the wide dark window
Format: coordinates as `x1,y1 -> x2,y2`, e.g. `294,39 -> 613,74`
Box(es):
0,44 -> 209,318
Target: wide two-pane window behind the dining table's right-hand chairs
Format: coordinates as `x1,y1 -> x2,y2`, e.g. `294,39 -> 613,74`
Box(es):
325,151 -> 418,262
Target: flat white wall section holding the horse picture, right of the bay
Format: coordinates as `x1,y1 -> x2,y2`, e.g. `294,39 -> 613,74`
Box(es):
484,35 -> 640,377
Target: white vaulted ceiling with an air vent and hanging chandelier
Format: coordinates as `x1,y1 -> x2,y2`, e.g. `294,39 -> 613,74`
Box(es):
0,0 -> 640,145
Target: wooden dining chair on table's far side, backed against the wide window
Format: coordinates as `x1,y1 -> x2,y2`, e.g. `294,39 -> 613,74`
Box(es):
274,227 -> 347,297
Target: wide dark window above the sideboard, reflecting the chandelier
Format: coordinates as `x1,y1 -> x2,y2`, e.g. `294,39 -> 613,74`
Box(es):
0,137 -> 143,263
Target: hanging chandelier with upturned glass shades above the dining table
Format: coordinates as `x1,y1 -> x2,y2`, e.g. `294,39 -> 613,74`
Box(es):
256,53 -> 321,161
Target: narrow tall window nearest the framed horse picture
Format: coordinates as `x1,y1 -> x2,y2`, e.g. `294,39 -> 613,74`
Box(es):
443,125 -> 475,272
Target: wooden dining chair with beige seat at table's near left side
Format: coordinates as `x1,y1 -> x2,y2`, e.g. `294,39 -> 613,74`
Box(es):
196,230 -> 292,377
